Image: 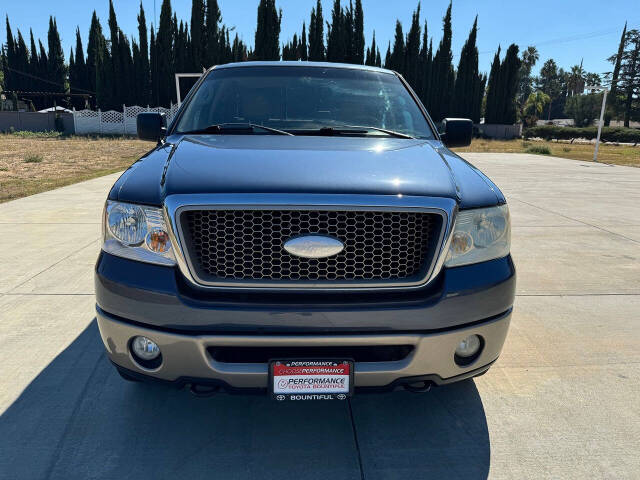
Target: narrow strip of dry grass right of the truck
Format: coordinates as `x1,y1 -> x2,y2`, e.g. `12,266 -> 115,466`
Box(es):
454,138 -> 640,167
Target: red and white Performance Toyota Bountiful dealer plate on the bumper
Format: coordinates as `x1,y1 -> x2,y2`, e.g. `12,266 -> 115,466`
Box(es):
269,359 -> 353,401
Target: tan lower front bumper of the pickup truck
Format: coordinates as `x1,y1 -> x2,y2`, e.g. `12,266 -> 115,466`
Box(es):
97,308 -> 511,389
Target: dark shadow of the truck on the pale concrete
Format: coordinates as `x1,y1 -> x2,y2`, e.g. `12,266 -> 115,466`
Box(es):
0,321 -> 489,479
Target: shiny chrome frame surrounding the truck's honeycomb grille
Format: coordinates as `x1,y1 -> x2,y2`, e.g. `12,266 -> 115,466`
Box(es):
165,194 -> 457,290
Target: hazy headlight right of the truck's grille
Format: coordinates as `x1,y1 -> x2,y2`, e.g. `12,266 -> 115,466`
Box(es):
445,205 -> 511,267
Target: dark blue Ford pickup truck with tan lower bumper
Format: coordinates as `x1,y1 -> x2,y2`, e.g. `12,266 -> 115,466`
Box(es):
95,62 -> 516,401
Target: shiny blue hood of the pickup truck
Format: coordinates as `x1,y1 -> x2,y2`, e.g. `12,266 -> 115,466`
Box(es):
112,135 -> 496,206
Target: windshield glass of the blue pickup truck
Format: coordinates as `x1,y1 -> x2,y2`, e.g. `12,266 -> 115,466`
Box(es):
175,66 -> 434,139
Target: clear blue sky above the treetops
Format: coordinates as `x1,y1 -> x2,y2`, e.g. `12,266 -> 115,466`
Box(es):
0,0 -> 640,78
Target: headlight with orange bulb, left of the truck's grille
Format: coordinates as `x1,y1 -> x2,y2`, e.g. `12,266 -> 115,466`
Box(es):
102,201 -> 176,265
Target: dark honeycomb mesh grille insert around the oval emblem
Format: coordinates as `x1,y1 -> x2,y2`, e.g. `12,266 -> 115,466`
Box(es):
180,209 -> 442,284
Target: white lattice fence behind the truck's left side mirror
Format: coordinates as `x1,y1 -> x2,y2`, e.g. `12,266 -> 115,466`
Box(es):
73,104 -> 179,135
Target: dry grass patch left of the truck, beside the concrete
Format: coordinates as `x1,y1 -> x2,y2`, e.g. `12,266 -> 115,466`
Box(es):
0,132 -> 154,203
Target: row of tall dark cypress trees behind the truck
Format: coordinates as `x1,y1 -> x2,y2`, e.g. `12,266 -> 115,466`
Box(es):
0,0 -> 640,123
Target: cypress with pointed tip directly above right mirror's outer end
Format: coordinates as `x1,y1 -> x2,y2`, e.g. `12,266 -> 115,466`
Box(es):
451,16 -> 479,118
